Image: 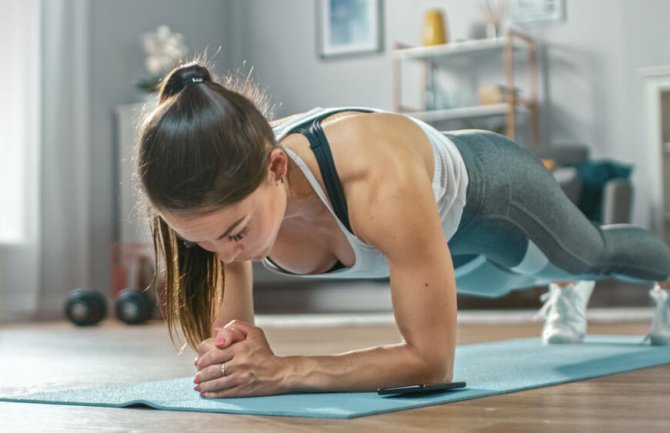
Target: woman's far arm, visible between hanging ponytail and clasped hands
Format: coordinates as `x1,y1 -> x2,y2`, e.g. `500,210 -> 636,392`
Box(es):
212,261 -> 254,334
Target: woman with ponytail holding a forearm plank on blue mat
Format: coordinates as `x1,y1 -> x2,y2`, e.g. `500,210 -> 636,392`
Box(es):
138,64 -> 670,397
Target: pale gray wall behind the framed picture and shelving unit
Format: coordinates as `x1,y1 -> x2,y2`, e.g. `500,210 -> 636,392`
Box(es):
235,0 -> 670,226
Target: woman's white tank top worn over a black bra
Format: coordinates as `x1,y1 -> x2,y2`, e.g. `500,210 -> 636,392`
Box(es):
263,107 -> 468,279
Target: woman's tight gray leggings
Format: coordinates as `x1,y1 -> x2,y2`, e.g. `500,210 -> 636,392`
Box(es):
445,131 -> 670,296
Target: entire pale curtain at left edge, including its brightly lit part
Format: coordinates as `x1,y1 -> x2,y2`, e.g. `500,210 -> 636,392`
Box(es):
0,0 -> 91,321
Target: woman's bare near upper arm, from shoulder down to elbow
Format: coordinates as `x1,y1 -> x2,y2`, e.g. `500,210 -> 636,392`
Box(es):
350,155 -> 456,363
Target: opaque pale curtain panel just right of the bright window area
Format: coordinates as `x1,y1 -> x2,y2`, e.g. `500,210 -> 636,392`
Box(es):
35,0 -> 94,319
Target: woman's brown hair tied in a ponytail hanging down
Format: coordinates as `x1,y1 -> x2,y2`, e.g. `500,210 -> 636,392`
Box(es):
137,62 -> 276,347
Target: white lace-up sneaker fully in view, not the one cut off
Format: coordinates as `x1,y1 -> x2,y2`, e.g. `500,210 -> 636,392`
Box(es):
537,281 -> 596,344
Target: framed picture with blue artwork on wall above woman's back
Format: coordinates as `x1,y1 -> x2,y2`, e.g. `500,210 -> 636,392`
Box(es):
316,0 -> 383,59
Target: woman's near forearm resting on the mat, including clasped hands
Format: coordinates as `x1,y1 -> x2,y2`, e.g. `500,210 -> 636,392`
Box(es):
195,321 -> 455,398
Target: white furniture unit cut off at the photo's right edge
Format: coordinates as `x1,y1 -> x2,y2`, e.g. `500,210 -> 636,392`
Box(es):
639,66 -> 670,244
